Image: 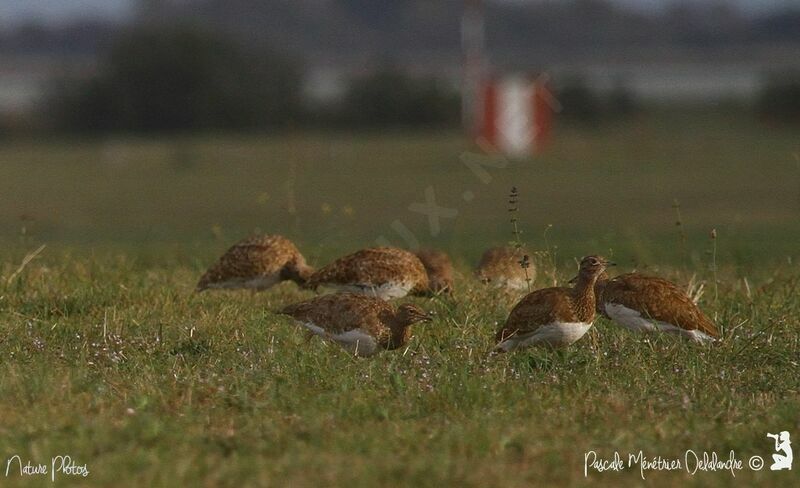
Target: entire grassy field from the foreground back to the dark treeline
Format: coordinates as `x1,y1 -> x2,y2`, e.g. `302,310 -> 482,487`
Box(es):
0,114 -> 800,486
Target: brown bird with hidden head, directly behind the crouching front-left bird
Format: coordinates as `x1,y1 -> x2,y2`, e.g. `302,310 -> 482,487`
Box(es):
307,247 -> 430,300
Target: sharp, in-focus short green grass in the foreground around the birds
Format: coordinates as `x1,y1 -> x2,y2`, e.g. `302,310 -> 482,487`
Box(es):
0,254 -> 800,486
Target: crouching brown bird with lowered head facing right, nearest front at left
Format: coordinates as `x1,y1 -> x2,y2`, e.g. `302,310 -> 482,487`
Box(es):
281,293 -> 430,357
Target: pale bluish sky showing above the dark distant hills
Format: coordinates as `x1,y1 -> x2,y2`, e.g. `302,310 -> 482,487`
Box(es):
0,0 -> 800,25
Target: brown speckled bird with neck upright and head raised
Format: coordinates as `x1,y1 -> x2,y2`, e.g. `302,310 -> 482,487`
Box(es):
495,256 -> 614,352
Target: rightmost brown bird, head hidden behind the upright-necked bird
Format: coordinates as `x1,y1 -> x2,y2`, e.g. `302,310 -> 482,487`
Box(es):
595,273 -> 719,342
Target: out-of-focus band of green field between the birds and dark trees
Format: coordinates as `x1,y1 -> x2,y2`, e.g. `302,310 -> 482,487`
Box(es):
0,113 -> 800,265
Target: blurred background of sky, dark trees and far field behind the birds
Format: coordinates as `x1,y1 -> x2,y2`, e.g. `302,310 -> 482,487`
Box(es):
0,0 -> 800,262
